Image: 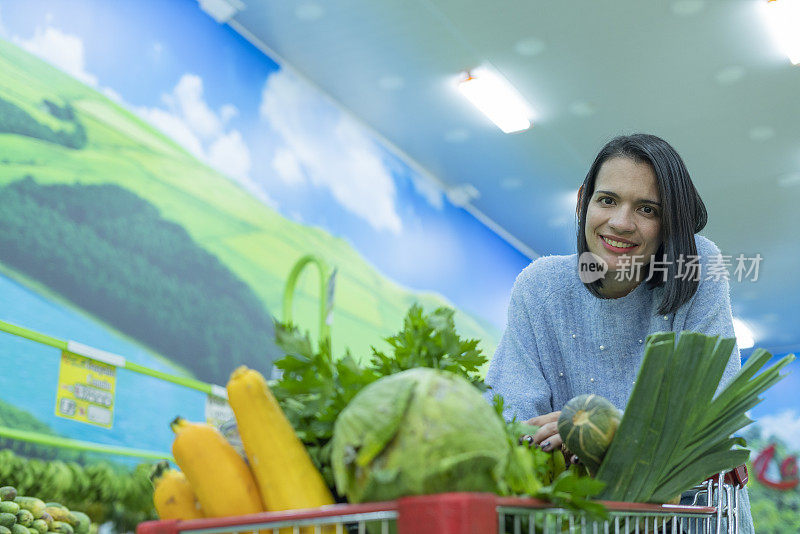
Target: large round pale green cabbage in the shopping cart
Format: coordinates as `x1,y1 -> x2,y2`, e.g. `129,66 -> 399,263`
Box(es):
331,368 -> 510,503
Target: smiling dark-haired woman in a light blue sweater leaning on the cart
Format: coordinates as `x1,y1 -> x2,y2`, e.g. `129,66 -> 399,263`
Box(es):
486,134 -> 752,533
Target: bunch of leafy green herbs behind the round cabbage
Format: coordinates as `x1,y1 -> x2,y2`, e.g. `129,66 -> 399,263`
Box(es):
270,304 -> 487,494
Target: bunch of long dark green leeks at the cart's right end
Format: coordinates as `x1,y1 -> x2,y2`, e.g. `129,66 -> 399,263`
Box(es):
597,332 -> 794,503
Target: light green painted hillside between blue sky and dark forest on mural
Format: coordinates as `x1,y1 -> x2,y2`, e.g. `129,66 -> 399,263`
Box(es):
0,40 -> 499,372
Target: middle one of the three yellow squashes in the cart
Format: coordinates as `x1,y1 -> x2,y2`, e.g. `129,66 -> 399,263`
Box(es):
171,417 -> 264,517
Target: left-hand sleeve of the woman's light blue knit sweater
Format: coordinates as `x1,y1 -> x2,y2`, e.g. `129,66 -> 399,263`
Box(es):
486,275 -> 553,421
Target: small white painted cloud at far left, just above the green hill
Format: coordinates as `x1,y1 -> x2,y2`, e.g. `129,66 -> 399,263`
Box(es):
14,26 -> 97,87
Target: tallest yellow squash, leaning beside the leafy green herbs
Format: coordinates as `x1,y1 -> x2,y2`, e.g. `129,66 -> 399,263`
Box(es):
228,366 -> 333,512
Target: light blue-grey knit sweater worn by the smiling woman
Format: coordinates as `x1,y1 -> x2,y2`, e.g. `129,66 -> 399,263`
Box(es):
486,235 -> 752,534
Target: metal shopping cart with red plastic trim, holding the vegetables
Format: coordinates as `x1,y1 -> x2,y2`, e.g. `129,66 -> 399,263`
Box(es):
136,466 -> 747,534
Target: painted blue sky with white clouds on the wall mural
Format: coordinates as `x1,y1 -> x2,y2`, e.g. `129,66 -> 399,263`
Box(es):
0,0 -> 528,328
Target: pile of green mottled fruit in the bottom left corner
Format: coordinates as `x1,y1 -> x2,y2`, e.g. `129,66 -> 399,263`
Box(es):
0,486 -> 92,534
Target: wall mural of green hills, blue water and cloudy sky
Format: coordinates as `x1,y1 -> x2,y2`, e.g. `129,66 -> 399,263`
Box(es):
0,0 -> 800,528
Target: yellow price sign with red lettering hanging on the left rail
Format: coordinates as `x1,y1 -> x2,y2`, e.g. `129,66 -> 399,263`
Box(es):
56,352 -> 117,428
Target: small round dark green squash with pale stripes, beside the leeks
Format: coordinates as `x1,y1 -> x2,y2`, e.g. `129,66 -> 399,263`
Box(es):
558,395 -> 622,474
